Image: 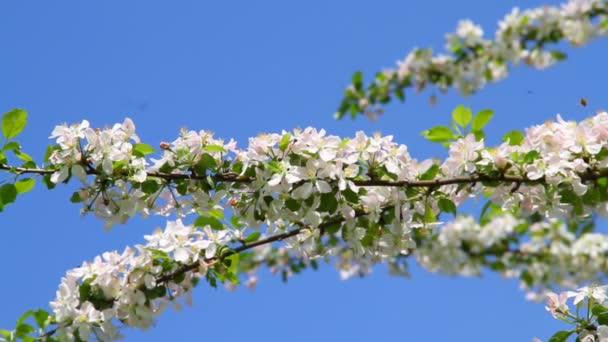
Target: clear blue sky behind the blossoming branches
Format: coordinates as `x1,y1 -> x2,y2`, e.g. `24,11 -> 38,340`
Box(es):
0,0 -> 608,342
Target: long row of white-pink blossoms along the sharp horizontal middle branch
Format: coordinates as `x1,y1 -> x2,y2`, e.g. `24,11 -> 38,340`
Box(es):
49,112 -> 608,274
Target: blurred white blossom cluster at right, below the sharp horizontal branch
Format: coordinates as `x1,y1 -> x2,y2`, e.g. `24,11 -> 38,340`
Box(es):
414,213 -> 608,299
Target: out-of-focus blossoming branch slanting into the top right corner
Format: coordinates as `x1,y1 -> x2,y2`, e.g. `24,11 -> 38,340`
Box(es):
335,0 -> 608,118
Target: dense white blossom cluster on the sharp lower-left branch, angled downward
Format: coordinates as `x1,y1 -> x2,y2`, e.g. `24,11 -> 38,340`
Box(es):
50,220 -> 231,341
